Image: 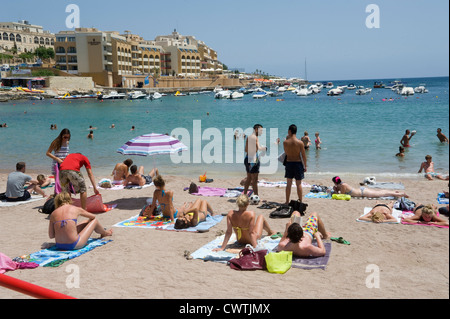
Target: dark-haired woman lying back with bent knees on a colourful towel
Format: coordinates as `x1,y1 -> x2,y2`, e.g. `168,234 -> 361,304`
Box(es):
175,199 -> 214,229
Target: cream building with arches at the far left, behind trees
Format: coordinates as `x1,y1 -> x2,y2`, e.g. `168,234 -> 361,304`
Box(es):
0,20 -> 55,54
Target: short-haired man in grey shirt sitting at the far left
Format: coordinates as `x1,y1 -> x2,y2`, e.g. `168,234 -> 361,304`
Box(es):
5,162 -> 46,202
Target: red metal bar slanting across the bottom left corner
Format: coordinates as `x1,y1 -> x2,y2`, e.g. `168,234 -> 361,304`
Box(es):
0,275 -> 75,299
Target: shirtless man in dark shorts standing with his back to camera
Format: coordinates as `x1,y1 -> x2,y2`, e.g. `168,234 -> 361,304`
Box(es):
283,125 -> 306,205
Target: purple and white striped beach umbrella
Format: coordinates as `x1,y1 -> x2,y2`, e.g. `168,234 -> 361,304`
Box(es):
117,133 -> 187,156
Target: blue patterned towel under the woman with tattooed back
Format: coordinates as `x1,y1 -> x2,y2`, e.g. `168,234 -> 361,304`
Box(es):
28,238 -> 112,267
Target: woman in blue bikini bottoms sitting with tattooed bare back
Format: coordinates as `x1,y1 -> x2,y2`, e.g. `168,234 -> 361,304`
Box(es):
48,192 -> 113,250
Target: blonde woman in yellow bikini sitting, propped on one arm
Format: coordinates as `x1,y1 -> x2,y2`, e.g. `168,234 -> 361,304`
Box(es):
214,194 -> 275,251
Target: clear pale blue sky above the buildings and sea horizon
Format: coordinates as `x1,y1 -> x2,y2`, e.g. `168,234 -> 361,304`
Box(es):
0,0 -> 449,81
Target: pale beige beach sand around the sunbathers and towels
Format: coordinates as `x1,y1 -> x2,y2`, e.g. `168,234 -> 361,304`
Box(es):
0,174 -> 449,299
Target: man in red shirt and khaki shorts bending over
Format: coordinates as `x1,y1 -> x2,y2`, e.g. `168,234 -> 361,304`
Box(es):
59,153 -> 100,210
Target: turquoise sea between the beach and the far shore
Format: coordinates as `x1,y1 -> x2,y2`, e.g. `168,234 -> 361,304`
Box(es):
0,77 -> 450,180
